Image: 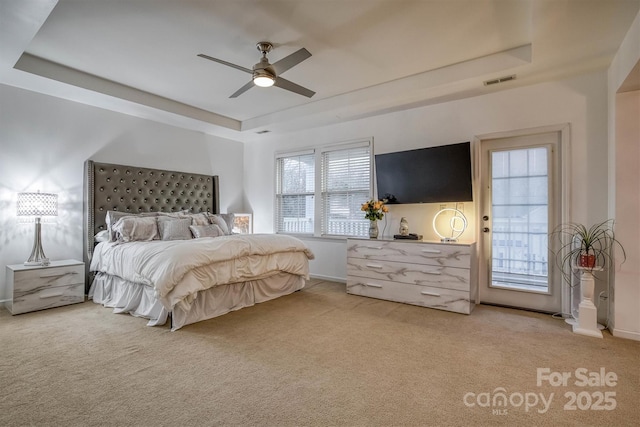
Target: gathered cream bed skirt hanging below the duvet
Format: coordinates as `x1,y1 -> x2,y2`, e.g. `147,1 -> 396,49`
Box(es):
89,273 -> 305,331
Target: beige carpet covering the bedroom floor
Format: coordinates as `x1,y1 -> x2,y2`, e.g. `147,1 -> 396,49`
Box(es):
0,280 -> 640,426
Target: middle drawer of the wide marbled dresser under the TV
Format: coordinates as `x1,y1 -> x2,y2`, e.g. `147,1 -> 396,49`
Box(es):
347,257 -> 470,292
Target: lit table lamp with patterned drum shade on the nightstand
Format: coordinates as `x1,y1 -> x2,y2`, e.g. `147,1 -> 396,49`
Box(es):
18,191 -> 58,265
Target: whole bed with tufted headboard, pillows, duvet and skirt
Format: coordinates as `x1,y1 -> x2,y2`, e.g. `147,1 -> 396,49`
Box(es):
84,160 -> 313,331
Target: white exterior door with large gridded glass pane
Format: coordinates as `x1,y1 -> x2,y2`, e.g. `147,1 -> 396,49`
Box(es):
480,132 -> 561,312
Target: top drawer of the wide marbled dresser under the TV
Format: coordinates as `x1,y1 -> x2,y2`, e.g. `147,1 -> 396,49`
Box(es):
347,239 -> 471,268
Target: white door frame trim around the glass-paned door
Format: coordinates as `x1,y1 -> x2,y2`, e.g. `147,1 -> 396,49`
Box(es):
473,123 -> 571,313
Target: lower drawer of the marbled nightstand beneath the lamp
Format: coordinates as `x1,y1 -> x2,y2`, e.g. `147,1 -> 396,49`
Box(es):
9,282 -> 84,314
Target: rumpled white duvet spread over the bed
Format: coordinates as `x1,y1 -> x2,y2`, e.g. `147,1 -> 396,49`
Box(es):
91,234 -> 313,310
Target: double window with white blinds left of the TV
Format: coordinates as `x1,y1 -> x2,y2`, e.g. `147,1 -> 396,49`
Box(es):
276,140 -> 372,237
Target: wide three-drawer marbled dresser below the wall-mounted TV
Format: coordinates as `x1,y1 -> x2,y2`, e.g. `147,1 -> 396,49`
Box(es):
347,239 -> 478,314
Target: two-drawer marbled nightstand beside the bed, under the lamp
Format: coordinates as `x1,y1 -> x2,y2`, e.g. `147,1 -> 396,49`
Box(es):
6,259 -> 84,314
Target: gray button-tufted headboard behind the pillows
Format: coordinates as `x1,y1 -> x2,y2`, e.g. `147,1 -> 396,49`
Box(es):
84,160 -> 220,286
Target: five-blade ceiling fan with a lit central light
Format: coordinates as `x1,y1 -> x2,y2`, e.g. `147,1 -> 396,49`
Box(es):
198,42 -> 315,98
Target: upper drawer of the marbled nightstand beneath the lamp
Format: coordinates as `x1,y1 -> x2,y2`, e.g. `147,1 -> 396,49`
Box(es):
13,264 -> 84,295
